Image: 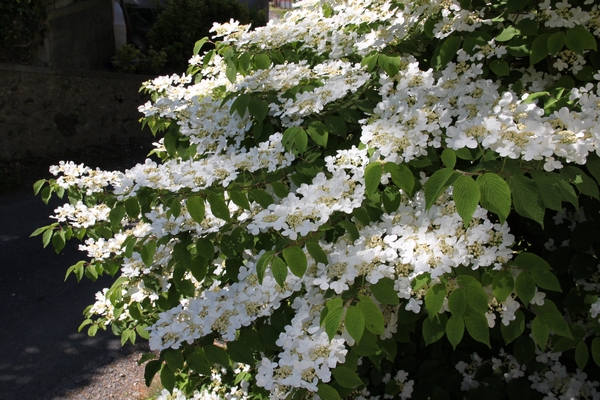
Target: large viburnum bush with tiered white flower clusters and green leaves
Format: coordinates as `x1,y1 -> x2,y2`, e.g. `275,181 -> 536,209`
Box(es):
35,0 -> 600,400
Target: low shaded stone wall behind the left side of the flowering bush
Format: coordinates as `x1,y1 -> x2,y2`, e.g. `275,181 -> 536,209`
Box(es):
0,63 -> 157,160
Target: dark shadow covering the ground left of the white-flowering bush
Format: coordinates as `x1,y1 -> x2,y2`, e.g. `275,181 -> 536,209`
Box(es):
0,140 -> 157,400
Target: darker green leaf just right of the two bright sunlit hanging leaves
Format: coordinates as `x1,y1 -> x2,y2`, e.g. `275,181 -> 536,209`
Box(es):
508,175 -> 546,228
